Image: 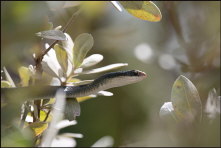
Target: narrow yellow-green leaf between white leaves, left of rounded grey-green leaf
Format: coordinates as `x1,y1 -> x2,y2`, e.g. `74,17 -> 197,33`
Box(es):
54,44 -> 68,72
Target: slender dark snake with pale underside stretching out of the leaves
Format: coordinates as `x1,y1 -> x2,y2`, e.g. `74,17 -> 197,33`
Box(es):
1,70 -> 147,101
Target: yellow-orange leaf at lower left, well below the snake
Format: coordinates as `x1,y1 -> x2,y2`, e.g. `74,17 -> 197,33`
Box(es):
29,122 -> 48,136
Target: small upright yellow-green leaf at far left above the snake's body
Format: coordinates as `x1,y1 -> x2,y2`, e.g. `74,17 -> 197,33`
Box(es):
18,66 -> 30,86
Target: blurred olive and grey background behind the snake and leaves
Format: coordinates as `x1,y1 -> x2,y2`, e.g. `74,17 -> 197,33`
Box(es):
1,1 -> 220,146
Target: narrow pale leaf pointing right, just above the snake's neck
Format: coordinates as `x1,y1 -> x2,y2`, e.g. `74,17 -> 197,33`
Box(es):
81,63 -> 128,74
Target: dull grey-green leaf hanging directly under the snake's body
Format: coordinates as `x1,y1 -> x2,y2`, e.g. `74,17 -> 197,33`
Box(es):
64,98 -> 81,121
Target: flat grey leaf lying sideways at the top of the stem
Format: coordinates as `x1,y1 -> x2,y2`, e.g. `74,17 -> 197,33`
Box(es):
36,30 -> 67,41
